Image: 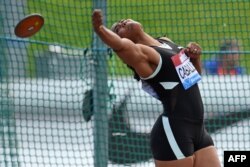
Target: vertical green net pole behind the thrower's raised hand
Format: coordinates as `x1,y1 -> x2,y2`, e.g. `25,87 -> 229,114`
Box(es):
92,0 -> 109,167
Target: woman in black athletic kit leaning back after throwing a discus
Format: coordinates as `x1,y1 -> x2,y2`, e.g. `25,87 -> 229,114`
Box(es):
92,9 -> 220,167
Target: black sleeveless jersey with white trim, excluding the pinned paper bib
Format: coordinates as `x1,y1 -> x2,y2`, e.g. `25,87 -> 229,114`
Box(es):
141,39 -> 204,121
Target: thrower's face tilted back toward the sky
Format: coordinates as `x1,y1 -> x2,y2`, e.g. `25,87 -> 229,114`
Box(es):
111,19 -> 142,40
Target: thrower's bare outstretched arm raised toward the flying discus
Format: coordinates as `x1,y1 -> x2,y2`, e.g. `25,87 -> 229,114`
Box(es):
92,9 -> 159,77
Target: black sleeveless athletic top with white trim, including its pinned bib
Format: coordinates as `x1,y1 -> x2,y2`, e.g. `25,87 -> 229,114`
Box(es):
141,39 -> 203,121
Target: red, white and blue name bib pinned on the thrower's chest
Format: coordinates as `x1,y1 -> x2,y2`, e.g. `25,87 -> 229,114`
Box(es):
171,50 -> 201,90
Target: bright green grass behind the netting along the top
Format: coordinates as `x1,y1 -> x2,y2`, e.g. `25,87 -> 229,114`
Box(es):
27,0 -> 250,75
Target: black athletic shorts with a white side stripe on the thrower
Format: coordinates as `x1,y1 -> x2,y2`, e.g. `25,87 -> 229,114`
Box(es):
150,115 -> 214,161
